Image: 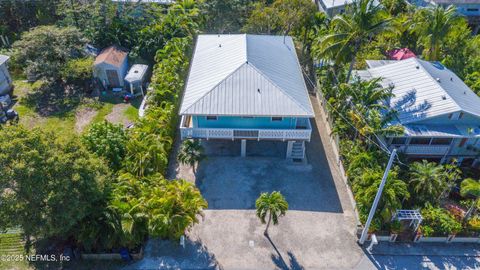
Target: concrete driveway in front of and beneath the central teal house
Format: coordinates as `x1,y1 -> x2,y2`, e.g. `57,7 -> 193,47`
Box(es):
176,97 -> 363,269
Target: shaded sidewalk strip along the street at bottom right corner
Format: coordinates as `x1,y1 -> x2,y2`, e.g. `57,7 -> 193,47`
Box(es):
371,242 -> 480,257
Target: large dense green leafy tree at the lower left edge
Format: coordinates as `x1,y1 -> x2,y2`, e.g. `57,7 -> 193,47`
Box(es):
0,126 -> 111,243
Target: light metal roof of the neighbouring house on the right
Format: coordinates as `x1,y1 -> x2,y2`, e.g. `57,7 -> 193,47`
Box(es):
359,58 -> 480,124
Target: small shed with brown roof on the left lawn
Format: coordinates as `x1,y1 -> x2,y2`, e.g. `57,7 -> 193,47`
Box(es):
94,46 -> 128,88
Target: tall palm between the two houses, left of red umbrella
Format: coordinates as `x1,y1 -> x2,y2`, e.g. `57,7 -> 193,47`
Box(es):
320,0 -> 390,82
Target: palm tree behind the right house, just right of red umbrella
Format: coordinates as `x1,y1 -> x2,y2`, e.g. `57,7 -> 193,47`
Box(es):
412,5 -> 460,61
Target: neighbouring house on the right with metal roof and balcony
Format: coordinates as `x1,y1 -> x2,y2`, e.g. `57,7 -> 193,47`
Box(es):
357,58 -> 480,165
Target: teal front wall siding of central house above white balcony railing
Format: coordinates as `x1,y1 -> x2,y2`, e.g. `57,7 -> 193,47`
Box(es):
193,116 -> 297,129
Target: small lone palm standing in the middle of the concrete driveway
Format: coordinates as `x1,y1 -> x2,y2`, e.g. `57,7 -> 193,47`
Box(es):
255,191 -> 288,235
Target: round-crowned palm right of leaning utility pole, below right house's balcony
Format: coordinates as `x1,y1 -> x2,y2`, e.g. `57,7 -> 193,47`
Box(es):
410,160 -> 447,205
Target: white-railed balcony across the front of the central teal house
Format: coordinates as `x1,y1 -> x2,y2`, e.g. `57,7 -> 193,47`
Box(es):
180,116 -> 312,141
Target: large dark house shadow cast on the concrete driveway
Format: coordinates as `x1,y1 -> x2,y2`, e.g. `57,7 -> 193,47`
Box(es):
196,118 -> 343,213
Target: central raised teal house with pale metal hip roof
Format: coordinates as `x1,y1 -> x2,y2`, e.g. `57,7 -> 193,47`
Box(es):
180,34 -> 314,159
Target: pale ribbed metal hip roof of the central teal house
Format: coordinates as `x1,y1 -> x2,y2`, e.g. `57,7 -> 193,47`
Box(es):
180,34 -> 314,117
